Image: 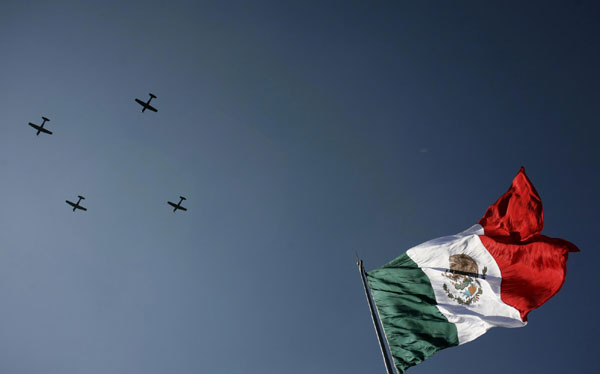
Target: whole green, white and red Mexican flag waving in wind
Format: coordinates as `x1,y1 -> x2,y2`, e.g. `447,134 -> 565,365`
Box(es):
366,168 -> 579,373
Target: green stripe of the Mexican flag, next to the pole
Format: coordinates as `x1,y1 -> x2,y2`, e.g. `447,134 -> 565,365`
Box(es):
367,253 -> 458,373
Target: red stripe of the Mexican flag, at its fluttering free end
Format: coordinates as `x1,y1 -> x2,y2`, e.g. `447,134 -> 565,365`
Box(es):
479,168 -> 579,321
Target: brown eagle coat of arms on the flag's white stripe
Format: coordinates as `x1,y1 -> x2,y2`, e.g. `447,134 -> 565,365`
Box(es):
442,253 -> 487,305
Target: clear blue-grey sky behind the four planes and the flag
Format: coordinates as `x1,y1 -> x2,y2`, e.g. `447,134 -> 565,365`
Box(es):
0,1 -> 600,374
